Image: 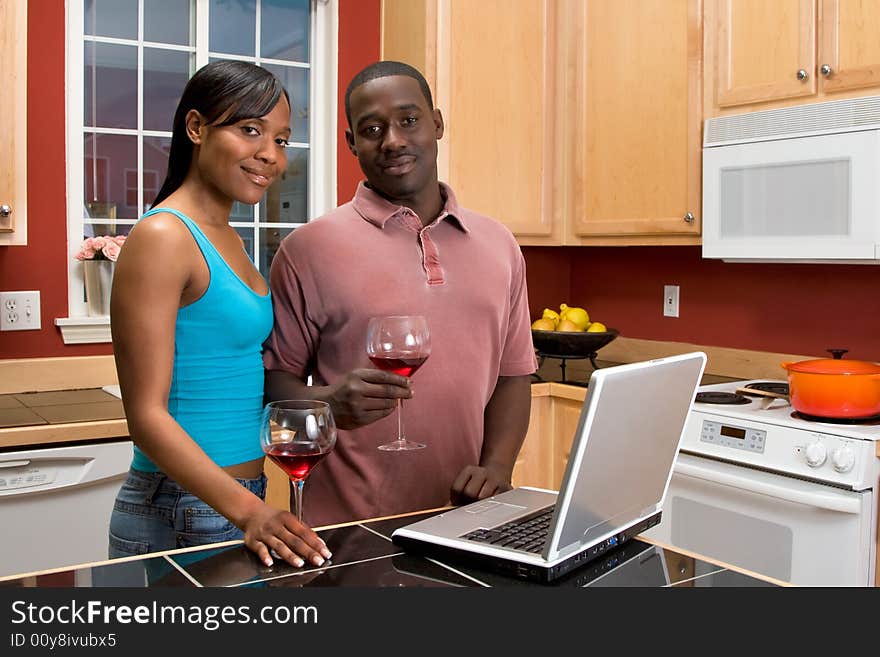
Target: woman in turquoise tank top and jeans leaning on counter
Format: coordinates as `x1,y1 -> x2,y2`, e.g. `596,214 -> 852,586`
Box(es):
110,62 -> 330,567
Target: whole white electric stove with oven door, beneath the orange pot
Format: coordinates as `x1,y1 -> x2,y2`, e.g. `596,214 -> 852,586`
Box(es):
646,381 -> 880,586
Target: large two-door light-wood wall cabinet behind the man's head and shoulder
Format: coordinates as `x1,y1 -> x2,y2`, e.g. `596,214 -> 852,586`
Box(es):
382,0 -> 702,245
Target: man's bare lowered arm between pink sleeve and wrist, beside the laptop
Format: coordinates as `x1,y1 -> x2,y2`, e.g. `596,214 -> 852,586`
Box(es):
480,376 -> 532,479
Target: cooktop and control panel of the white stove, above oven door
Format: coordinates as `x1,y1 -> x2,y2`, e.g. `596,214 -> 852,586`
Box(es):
681,380 -> 880,490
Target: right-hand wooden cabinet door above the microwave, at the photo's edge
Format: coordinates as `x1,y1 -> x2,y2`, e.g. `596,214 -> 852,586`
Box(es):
818,0 -> 880,92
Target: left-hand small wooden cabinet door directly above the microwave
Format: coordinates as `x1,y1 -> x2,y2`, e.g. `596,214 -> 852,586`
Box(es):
706,0 -> 816,108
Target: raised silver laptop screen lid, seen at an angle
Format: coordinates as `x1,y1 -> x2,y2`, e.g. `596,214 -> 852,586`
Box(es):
544,352 -> 706,559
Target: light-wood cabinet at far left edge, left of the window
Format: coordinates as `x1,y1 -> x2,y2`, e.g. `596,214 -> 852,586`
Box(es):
0,0 -> 27,246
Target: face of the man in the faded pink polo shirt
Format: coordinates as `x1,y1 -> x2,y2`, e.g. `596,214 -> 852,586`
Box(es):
345,75 -> 443,200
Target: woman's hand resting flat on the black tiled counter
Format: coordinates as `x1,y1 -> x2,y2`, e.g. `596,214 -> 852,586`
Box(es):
242,503 -> 332,568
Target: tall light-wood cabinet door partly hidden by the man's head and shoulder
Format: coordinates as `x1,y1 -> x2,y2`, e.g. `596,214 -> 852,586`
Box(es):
436,0 -> 558,237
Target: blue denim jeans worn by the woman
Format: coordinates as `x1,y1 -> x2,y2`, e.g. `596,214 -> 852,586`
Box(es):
109,468 -> 266,559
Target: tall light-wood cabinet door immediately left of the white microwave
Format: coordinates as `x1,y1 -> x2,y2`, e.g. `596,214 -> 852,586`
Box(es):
564,0 -> 702,238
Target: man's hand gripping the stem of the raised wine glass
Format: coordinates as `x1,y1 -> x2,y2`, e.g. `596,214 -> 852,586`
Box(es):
327,368 -> 412,429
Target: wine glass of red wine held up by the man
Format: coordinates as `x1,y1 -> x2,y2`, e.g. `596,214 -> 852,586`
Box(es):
367,315 -> 431,452
